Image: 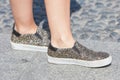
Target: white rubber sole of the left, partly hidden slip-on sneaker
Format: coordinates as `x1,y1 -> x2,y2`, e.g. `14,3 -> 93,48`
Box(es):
10,41 -> 48,52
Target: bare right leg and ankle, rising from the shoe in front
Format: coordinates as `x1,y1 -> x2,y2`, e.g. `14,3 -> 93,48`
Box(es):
45,0 -> 75,48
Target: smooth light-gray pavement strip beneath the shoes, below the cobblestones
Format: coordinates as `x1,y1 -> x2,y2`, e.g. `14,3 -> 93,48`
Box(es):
0,34 -> 120,80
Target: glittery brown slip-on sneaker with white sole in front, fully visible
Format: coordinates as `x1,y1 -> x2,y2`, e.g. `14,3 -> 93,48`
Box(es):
48,41 -> 112,67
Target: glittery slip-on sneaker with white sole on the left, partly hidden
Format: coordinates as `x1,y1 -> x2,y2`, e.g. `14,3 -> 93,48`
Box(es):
10,24 -> 50,52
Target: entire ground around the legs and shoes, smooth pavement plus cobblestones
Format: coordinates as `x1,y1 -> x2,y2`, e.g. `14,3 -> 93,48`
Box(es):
0,0 -> 120,80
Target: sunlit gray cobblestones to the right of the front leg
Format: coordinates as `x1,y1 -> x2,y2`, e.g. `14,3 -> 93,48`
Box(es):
71,0 -> 120,42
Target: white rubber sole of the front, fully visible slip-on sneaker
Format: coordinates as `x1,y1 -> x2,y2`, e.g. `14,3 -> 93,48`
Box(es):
47,55 -> 112,67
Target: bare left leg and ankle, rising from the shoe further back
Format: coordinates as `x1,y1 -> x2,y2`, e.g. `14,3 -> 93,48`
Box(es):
10,0 -> 37,34
